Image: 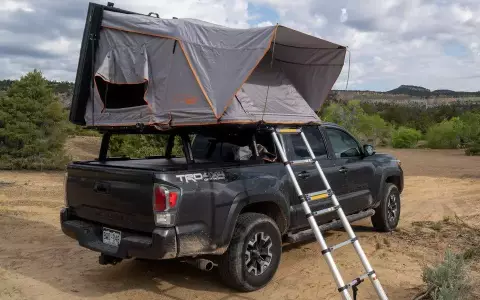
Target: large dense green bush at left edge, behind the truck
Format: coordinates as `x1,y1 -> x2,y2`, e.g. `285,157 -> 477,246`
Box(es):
0,71 -> 67,169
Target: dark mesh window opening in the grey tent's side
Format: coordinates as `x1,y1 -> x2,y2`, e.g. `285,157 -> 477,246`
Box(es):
95,76 -> 148,109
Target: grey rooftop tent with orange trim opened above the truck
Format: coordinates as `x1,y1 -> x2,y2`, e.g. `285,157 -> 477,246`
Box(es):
70,5 -> 346,129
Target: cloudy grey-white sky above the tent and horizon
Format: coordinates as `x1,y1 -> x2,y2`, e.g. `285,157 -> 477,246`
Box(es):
0,0 -> 480,91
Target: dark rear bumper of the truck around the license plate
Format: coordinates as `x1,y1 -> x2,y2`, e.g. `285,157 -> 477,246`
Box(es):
60,208 -> 178,259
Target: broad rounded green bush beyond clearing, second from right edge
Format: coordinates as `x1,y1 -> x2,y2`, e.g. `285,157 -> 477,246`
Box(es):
426,118 -> 464,149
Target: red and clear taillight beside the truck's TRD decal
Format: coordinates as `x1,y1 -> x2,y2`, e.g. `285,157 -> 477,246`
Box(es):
153,185 -> 179,226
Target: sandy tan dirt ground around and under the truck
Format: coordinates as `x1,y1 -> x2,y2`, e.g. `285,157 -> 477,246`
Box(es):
0,138 -> 480,300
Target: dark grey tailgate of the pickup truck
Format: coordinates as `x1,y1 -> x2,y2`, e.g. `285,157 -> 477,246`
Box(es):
66,164 -> 155,232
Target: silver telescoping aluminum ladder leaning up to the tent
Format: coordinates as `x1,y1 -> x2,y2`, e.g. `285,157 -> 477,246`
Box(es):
272,128 -> 388,300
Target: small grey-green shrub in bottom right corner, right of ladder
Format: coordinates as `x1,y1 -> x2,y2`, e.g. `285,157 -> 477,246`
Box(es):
422,251 -> 471,300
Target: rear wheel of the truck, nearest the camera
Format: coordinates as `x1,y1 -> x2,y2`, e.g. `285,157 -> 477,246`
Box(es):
218,213 -> 282,292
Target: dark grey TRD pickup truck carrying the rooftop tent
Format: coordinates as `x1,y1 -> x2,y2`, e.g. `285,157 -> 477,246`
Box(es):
60,123 -> 403,291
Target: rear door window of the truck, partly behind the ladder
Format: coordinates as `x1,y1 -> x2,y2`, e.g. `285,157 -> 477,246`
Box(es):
284,127 -> 327,160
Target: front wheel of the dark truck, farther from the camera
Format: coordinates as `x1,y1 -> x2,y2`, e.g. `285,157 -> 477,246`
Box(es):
372,183 -> 400,232
